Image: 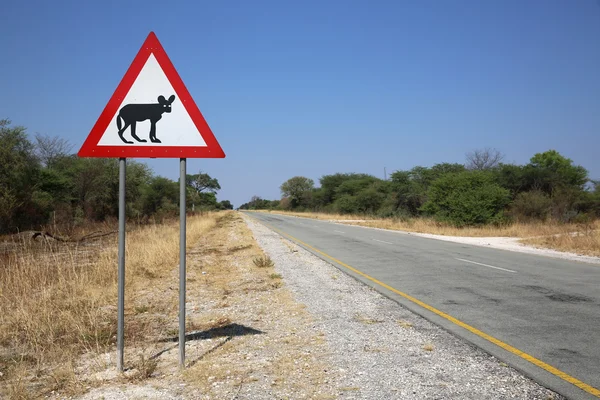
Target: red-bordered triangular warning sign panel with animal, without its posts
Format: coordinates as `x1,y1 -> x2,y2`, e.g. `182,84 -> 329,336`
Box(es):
77,32 -> 225,158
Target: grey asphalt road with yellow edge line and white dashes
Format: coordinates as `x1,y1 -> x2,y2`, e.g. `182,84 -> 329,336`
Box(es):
249,213 -> 600,399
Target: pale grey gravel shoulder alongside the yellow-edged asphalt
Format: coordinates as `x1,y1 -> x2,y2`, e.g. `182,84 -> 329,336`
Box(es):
243,216 -> 562,400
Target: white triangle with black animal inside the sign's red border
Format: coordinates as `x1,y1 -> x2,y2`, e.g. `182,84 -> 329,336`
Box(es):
98,54 -> 206,147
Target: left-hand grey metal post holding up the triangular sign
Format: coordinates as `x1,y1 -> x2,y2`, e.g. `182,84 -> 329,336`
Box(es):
117,158 -> 126,372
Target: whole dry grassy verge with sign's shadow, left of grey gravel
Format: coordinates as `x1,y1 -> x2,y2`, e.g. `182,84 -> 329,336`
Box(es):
0,211 -> 335,400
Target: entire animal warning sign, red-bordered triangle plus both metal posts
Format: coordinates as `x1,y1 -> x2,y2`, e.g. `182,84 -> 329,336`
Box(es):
77,32 -> 225,372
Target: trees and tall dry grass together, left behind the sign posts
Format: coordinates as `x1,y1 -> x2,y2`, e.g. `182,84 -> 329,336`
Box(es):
0,120 -> 233,399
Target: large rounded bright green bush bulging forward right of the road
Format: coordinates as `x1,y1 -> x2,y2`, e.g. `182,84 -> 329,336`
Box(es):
422,171 -> 510,227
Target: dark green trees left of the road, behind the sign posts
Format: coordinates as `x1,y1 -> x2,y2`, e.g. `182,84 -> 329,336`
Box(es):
0,119 -> 233,233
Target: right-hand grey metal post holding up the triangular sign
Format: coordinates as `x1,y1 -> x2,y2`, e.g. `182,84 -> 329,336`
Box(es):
179,158 -> 186,368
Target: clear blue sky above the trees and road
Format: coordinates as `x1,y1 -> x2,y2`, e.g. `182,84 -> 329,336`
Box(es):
0,0 -> 600,206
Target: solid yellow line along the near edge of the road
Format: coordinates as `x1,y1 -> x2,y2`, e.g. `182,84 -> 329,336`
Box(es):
248,217 -> 600,398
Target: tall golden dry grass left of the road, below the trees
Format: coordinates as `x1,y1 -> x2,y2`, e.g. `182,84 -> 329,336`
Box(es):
0,215 -> 216,399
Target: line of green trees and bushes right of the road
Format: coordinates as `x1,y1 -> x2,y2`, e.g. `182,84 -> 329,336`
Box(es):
244,149 -> 600,226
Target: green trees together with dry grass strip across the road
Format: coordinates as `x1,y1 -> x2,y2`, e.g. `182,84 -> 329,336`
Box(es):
240,149 -> 600,255
